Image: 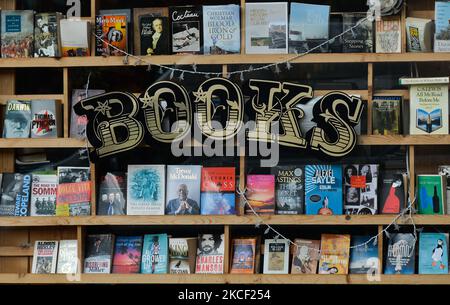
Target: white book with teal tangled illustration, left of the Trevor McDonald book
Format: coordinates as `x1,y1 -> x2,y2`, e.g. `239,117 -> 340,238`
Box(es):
127,165 -> 166,215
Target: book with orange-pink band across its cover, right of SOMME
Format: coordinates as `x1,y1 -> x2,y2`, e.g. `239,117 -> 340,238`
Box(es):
56,166 -> 91,216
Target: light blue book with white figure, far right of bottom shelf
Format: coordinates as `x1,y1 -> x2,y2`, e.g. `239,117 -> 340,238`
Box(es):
419,233 -> 448,274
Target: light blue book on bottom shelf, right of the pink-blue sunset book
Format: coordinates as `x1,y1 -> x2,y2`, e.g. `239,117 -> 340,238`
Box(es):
141,234 -> 169,274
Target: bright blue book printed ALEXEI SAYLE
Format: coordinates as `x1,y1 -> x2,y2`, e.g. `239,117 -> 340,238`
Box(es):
305,165 -> 343,215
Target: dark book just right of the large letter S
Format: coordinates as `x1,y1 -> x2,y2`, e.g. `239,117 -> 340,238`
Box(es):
372,96 -> 402,136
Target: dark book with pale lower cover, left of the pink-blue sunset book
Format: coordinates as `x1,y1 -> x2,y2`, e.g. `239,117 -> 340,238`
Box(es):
84,234 -> 114,273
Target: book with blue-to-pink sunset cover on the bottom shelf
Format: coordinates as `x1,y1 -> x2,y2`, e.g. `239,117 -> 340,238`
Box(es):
112,236 -> 142,273
